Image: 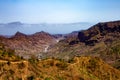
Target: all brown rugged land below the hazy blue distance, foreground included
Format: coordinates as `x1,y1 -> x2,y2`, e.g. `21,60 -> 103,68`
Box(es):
0,21 -> 120,80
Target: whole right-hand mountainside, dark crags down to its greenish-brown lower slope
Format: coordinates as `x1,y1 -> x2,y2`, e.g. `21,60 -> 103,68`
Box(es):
47,21 -> 120,68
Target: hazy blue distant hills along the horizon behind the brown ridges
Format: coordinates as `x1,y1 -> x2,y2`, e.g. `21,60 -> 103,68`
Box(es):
0,22 -> 93,35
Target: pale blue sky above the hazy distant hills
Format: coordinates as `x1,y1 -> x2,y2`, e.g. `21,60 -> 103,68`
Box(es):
0,0 -> 120,23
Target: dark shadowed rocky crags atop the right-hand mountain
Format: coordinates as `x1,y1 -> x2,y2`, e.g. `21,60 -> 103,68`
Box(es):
78,21 -> 120,45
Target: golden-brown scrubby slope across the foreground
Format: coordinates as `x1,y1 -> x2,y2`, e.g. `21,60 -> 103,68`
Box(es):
0,57 -> 120,80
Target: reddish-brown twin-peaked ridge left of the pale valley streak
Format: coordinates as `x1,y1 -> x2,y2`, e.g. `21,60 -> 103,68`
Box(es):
0,31 -> 56,58
